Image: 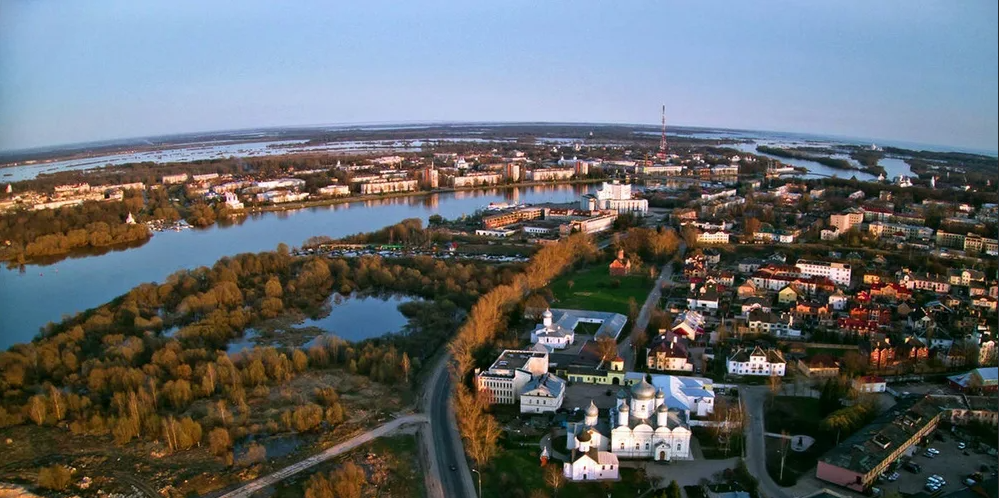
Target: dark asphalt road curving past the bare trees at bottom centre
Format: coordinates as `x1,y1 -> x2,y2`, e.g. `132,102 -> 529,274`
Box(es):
424,358 -> 476,498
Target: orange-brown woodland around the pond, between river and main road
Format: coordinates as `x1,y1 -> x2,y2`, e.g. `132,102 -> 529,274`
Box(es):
0,220 -> 523,488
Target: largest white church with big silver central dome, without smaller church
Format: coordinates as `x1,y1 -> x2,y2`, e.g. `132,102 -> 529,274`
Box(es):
610,378 -> 691,461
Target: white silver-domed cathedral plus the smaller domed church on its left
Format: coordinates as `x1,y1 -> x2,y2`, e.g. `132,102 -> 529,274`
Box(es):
566,378 -> 692,461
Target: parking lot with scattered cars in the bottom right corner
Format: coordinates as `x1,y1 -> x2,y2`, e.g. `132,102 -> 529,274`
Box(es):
877,437 -> 997,493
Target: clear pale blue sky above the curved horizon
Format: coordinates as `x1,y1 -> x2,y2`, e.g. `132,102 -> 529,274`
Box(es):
0,0 -> 999,151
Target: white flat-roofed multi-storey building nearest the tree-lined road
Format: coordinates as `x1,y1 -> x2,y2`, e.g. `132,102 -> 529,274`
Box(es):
475,349 -> 552,405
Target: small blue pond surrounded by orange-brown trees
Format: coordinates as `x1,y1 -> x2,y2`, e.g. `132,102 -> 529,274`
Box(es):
296,293 -> 418,347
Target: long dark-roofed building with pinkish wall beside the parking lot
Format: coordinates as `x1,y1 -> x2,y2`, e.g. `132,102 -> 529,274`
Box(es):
815,398 -> 945,492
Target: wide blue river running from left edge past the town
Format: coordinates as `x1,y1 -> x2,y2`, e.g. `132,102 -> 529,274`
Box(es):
0,185 -> 595,350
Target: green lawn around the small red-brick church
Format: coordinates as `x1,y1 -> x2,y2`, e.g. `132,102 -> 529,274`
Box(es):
548,265 -> 653,315
